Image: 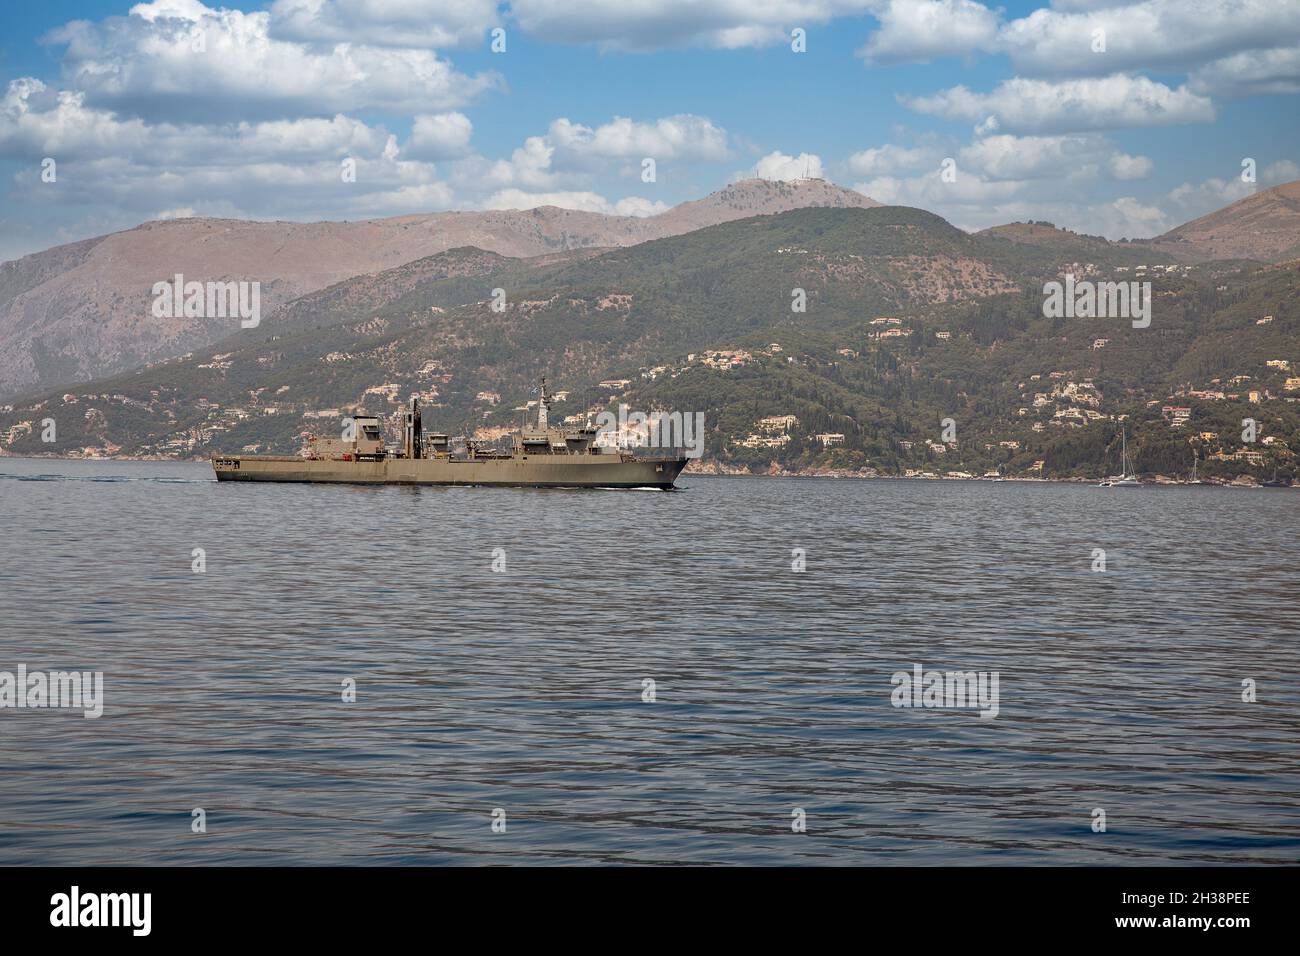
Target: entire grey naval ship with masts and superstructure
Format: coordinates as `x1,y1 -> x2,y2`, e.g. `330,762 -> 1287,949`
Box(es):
212,378 -> 686,490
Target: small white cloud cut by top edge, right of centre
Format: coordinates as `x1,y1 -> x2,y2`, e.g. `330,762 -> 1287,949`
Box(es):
858,0 -> 998,64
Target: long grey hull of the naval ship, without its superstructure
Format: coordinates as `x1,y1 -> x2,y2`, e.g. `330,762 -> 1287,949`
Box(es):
212,454 -> 686,490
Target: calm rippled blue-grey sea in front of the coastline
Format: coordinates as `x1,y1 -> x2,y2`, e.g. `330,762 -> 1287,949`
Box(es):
0,459 -> 1300,865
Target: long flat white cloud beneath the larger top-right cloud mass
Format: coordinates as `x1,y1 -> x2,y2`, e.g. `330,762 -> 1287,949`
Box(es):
900,74 -> 1214,133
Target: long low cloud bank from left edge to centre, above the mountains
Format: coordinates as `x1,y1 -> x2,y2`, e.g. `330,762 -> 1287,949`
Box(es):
0,78 -> 702,244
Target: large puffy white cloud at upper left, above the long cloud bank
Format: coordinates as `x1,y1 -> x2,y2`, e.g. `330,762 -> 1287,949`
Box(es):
49,0 -> 501,118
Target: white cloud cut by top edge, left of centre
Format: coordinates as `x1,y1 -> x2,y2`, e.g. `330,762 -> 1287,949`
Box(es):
270,0 -> 501,47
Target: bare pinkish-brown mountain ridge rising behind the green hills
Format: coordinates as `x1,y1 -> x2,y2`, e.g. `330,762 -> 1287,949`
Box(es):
0,179 -> 878,398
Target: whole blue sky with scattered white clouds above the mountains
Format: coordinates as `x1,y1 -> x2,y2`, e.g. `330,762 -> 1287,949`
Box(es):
0,0 -> 1300,259
